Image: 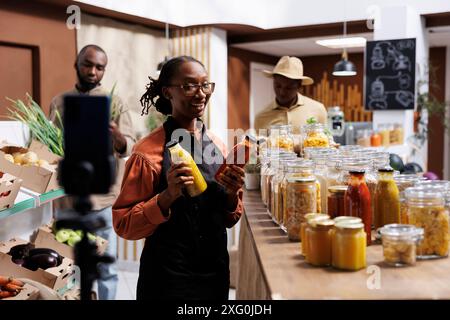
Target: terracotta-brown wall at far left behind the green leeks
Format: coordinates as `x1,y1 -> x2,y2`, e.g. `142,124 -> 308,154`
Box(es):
0,0 -> 77,117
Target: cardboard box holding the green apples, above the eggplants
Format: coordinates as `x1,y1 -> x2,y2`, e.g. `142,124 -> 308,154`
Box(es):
33,225 -> 108,260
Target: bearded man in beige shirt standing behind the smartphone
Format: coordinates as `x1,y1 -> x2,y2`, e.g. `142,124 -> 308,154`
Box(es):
50,45 -> 136,300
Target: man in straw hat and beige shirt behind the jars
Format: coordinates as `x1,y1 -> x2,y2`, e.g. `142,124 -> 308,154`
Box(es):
255,56 -> 327,133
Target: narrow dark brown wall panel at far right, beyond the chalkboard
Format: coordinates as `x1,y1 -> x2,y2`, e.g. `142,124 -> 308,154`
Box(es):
428,47 -> 446,179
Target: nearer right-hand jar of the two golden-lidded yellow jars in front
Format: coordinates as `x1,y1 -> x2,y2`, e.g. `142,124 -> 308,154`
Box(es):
331,220 -> 367,270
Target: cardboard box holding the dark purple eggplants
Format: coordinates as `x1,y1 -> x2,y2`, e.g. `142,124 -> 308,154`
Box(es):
0,239 -> 73,291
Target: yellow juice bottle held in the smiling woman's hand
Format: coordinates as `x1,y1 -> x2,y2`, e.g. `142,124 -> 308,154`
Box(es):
166,141 -> 207,197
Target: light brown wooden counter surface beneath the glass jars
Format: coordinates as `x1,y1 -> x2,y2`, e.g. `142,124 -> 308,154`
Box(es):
236,191 -> 450,300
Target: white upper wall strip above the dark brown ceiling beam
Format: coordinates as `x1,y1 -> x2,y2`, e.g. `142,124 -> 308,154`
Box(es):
76,0 -> 450,29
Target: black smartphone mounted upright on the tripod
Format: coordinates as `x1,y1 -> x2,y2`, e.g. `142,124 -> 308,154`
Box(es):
58,95 -> 116,195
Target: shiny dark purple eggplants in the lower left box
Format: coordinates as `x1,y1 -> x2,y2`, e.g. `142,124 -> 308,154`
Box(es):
8,243 -> 63,271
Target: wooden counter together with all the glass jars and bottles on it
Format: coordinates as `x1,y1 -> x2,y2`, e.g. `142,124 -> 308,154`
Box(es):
236,124 -> 450,299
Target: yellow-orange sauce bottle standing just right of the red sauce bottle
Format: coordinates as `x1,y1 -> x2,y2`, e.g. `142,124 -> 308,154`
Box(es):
374,168 -> 400,229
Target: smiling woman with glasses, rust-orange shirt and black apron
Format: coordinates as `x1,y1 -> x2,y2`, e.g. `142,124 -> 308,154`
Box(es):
113,56 -> 244,300
